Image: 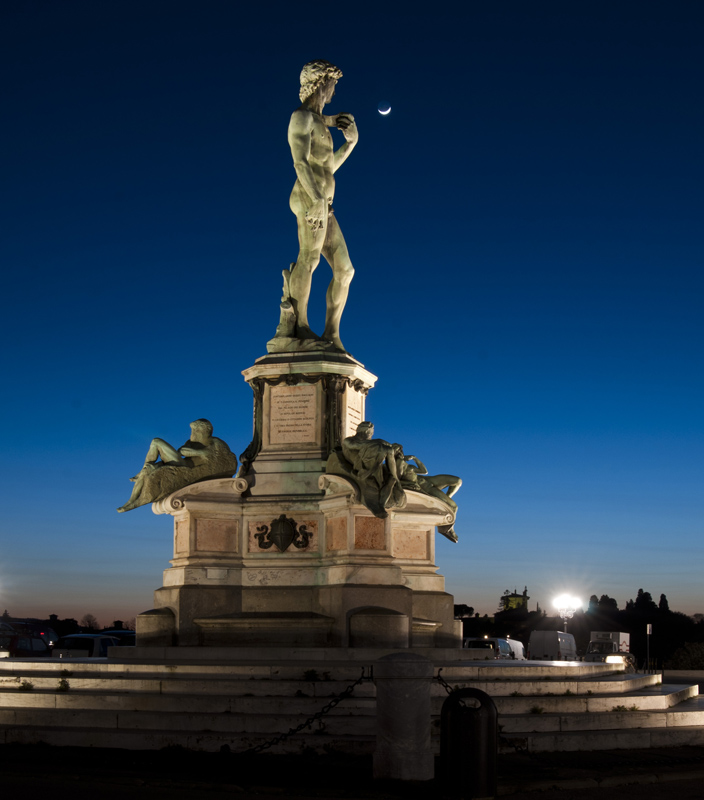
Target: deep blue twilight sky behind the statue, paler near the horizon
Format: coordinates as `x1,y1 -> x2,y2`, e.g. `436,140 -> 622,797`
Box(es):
0,0 -> 704,622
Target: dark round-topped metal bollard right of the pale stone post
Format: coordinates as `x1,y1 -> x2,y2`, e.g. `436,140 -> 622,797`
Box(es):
440,688 -> 499,800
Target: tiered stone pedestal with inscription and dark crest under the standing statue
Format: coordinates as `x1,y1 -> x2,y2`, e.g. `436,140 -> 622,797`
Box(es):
137,353 -> 461,648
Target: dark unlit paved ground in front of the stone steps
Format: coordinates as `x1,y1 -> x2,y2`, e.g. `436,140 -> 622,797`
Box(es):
0,745 -> 704,800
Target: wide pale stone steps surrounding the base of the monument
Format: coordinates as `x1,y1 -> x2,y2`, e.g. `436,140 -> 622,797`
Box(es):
0,648 -> 704,754
